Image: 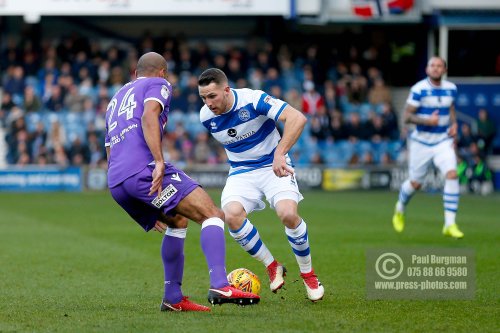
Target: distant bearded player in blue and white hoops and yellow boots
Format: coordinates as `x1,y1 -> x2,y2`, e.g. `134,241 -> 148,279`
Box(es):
392,57 -> 464,238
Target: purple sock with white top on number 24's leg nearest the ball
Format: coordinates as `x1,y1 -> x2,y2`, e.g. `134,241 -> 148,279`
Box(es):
200,217 -> 229,289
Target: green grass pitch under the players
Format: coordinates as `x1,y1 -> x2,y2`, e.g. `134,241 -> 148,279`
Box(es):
0,191 -> 500,333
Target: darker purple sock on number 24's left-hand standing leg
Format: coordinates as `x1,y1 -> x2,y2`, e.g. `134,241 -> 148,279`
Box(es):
161,228 -> 187,304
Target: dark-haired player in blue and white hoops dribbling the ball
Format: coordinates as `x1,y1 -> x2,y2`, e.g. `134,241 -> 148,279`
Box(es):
198,68 -> 324,301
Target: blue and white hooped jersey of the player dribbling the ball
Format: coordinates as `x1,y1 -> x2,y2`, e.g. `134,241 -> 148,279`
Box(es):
200,89 -> 288,176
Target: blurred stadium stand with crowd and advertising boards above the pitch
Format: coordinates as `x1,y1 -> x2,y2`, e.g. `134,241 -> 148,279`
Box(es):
0,0 -> 500,194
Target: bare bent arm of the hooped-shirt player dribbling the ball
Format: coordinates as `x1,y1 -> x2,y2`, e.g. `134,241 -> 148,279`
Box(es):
273,105 -> 307,177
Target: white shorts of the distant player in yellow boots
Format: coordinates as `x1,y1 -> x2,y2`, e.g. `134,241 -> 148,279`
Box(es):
408,140 -> 457,184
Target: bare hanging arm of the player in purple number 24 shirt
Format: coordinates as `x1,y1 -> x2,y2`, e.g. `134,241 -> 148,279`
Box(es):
141,100 -> 165,195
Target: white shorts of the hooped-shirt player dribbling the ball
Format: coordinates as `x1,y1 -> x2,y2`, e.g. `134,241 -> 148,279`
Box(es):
221,168 -> 304,214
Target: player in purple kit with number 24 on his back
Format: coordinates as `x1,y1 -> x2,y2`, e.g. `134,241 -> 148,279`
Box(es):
105,52 -> 259,311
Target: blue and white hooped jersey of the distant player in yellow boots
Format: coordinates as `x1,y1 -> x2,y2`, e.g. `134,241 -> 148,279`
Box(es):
406,78 -> 457,145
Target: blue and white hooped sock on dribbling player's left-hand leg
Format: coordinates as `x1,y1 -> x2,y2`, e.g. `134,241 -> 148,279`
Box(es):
229,219 -> 274,267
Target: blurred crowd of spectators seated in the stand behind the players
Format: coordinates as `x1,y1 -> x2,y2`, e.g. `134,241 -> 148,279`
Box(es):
0,33 -> 488,180
